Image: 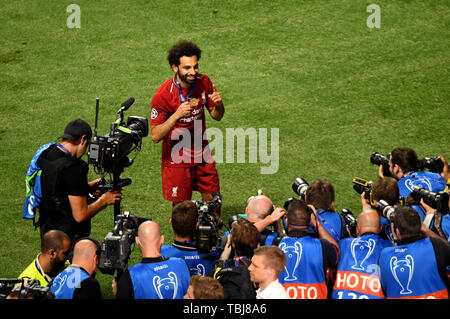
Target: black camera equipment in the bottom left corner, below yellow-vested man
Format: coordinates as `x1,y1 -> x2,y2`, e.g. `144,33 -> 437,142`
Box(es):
0,278 -> 55,300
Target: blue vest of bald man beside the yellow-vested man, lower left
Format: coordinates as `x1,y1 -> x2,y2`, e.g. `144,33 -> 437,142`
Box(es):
50,265 -> 90,299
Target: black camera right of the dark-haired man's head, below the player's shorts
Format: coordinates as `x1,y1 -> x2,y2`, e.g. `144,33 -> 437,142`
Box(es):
193,193 -> 223,253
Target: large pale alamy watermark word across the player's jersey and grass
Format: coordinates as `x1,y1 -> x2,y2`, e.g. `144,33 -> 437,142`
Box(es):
171,120 -> 280,174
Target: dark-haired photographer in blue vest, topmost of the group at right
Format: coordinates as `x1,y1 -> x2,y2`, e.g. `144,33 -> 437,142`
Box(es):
379,147 -> 446,200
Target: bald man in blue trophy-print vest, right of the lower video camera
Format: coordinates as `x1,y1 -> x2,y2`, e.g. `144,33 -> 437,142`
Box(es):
116,221 -> 191,299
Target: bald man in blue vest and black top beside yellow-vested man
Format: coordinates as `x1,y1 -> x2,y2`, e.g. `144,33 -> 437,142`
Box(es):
49,237 -> 103,300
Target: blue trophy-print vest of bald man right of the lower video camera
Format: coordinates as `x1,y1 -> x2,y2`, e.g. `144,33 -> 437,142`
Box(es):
128,258 -> 191,299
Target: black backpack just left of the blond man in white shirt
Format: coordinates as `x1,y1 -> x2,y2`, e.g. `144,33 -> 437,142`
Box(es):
214,260 -> 256,299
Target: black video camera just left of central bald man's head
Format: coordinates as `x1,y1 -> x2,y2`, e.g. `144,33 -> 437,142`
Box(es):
98,212 -> 151,275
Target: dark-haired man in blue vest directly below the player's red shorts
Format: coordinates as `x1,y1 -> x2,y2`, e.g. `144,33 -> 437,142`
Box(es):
161,201 -> 221,276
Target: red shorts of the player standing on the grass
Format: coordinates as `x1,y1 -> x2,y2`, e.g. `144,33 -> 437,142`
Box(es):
161,162 -> 220,202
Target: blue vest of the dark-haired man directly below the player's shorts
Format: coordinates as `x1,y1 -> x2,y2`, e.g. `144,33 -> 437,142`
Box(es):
161,242 -> 221,276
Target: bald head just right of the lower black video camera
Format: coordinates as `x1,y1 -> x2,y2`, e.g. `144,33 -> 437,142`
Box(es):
136,220 -> 164,257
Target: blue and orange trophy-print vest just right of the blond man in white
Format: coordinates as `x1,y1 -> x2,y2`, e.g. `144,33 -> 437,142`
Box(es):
278,236 -> 327,299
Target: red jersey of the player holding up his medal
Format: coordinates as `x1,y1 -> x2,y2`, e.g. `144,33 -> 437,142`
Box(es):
150,74 -> 214,167
